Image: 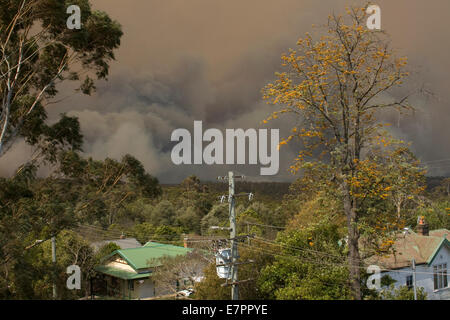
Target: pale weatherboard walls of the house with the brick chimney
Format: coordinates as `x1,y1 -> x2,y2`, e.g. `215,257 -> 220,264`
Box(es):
381,246 -> 450,300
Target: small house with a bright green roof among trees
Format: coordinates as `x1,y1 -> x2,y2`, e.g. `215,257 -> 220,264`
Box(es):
95,242 -> 192,299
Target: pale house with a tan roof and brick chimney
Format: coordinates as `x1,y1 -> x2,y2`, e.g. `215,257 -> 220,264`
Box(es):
367,218 -> 450,300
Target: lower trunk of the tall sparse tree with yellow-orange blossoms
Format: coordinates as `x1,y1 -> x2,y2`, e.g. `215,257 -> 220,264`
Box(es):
342,182 -> 361,300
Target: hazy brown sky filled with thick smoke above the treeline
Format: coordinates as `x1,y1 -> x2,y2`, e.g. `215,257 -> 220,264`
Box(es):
0,0 -> 450,183
